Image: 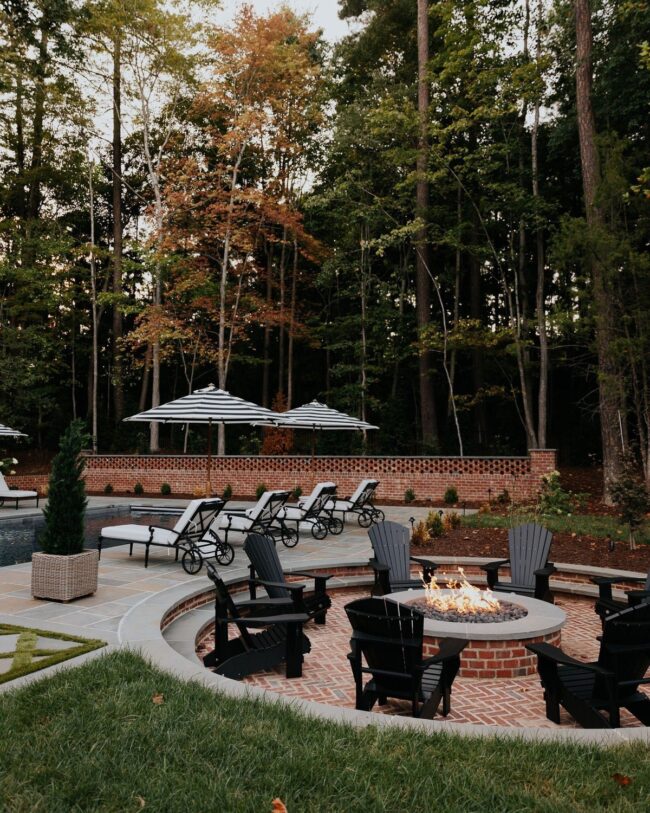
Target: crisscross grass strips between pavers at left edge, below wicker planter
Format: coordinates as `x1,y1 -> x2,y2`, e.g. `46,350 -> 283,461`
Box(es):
0,624 -> 106,683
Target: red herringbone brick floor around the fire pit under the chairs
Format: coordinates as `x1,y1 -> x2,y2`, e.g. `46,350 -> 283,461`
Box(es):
199,590 -> 639,728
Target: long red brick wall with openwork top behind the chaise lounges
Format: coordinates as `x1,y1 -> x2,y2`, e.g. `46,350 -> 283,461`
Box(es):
85,450 -> 556,502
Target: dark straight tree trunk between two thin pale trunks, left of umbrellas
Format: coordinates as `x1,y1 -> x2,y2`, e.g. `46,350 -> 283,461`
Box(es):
113,32 -> 124,424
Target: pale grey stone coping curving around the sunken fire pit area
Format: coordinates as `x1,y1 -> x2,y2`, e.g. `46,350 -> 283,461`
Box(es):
118,559 -> 650,747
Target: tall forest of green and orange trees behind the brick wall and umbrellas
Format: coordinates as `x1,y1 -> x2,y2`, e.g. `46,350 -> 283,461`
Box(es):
0,0 -> 650,488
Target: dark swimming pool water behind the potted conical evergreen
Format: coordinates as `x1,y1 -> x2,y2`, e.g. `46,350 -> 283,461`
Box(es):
0,506 -> 180,567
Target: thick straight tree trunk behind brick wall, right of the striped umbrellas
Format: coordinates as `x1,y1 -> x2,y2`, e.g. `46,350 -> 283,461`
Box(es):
415,0 -> 439,452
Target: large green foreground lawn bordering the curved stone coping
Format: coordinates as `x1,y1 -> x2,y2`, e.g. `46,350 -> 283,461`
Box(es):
0,652 -> 650,813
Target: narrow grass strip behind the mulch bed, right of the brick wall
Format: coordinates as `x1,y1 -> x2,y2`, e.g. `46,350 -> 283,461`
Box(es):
463,512 -> 650,544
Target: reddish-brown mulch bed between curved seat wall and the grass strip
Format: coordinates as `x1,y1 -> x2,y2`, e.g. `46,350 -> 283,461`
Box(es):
411,528 -> 650,573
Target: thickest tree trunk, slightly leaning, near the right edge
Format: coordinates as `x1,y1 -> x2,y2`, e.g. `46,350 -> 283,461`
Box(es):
574,0 -> 625,502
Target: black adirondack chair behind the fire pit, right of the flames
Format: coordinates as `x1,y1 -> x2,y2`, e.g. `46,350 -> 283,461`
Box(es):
481,522 -> 555,603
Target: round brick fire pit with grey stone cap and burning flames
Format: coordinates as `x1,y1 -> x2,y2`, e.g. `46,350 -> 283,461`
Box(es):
386,573 -> 566,679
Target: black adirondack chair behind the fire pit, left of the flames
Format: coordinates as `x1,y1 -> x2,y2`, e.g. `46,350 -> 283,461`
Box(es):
368,520 -> 438,596
